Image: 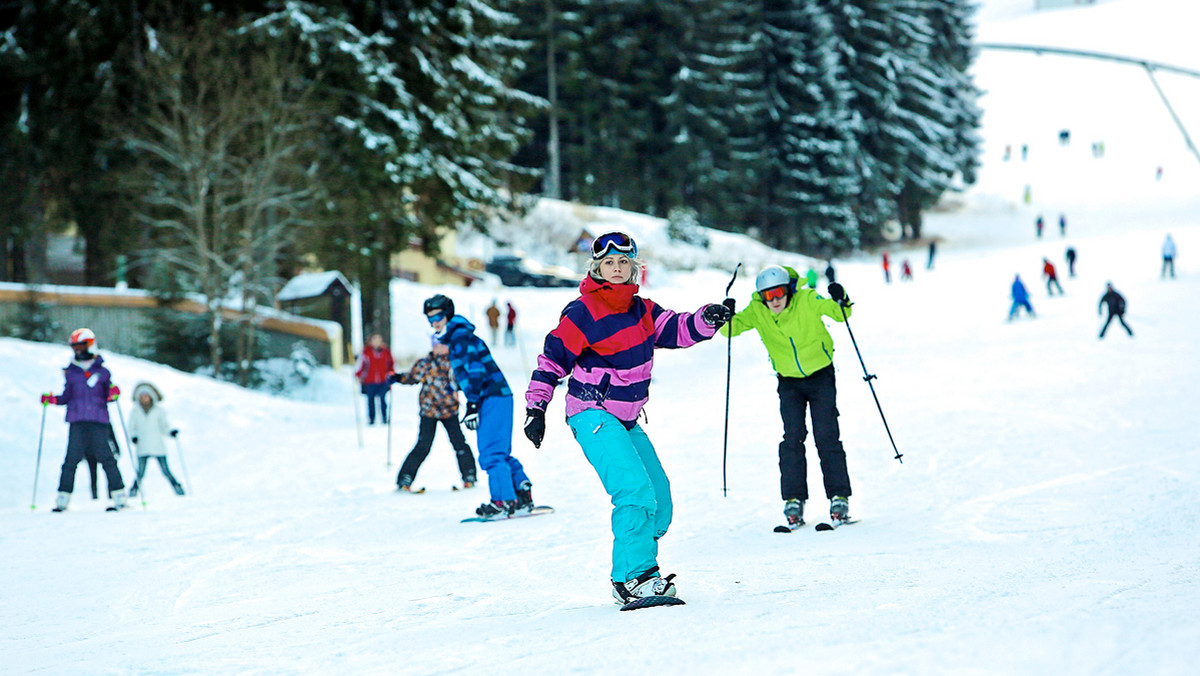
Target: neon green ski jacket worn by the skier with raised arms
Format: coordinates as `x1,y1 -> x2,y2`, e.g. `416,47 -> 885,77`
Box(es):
721,267 -> 851,378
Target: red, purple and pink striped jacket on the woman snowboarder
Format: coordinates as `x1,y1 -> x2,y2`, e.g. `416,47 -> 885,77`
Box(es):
526,276 -> 715,427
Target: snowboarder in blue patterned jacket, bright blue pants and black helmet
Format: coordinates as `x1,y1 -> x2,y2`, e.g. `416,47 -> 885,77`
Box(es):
422,293 -> 533,519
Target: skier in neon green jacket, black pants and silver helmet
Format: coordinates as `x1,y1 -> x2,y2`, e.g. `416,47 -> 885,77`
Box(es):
721,265 -> 851,528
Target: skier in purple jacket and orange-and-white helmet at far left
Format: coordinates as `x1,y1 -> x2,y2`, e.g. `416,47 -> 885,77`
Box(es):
42,329 -> 127,512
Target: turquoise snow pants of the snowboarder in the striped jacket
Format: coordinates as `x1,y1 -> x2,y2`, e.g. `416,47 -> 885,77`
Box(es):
566,409 -> 672,582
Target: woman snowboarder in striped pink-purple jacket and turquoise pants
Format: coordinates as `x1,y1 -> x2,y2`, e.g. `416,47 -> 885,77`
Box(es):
524,233 -> 733,609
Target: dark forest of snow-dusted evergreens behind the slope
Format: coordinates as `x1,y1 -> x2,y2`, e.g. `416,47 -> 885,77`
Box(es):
0,0 -> 979,374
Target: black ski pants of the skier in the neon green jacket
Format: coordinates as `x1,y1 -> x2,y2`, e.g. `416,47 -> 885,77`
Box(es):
778,365 -> 850,499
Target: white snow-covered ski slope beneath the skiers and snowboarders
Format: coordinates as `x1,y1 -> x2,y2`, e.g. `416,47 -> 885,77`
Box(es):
0,0 -> 1200,674
